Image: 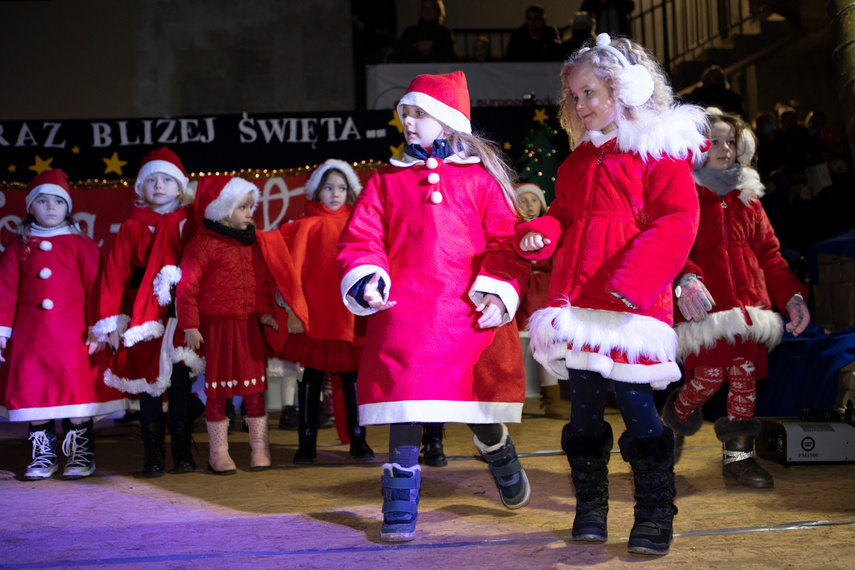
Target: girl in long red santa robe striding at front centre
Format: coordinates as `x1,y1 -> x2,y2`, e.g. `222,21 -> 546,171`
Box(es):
338,72 -> 530,541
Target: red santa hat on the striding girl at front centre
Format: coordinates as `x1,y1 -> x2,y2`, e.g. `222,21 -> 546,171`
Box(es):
398,71 -> 472,135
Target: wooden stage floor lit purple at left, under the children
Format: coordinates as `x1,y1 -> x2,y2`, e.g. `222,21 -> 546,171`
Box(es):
0,400 -> 855,569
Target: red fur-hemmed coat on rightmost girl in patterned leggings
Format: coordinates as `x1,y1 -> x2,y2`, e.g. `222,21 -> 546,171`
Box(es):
675,178 -> 807,369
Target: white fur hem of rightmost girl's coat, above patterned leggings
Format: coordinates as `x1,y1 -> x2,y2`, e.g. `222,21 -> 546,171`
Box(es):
675,307 -> 784,362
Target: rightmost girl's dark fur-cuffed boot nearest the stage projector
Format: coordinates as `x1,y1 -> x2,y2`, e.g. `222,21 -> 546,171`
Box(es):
713,416 -> 774,489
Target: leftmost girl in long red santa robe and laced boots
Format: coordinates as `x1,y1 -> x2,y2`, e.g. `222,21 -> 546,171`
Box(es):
0,170 -> 127,480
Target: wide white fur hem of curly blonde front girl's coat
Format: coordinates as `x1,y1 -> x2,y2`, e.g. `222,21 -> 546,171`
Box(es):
528,303 -> 679,384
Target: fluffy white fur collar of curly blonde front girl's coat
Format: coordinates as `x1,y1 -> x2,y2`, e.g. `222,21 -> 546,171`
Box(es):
582,105 -> 707,161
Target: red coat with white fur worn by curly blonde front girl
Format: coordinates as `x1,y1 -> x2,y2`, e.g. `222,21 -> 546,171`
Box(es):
514,103 -> 705,388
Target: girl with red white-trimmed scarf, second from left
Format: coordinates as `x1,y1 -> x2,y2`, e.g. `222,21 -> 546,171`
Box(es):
95,147 -> 199,477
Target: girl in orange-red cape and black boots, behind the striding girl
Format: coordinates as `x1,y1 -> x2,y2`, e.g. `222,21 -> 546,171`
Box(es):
262,159 -> 374,463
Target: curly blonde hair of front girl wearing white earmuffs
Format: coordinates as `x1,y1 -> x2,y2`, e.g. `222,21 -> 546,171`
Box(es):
560,38 -> 674,148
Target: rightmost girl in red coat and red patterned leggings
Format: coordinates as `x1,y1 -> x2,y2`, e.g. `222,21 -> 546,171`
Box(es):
662,109 -> 810,488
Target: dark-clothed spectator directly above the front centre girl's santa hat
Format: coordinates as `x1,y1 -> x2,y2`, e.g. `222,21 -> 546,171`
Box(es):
392,0 -> 457,63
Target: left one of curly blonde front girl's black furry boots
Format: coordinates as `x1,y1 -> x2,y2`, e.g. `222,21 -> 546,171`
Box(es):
561,422 -> 614,542
